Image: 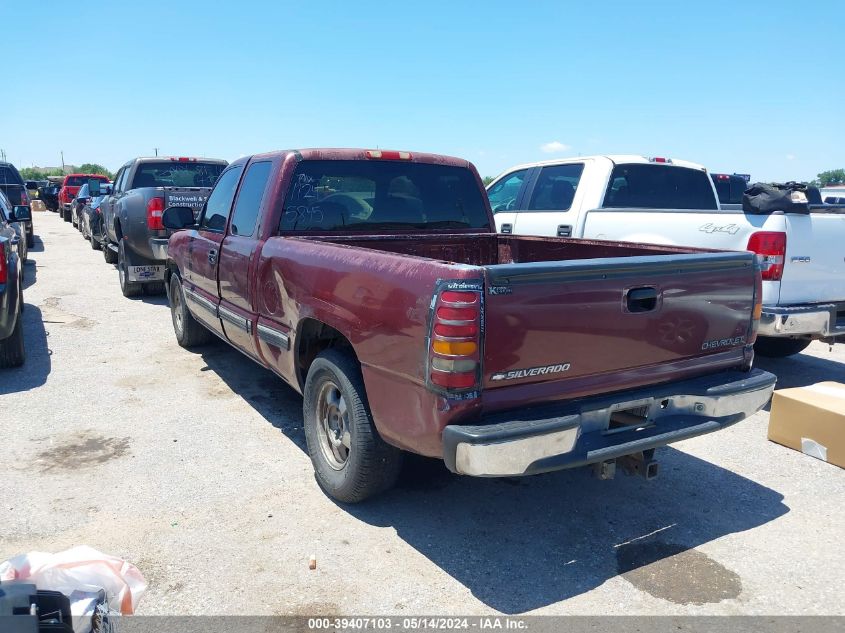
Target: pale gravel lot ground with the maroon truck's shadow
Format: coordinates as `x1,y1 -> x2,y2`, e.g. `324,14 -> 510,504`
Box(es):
0,213 -> 845,615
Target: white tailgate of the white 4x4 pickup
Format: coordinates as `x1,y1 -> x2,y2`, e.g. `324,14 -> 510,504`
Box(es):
778,213 -> 845,305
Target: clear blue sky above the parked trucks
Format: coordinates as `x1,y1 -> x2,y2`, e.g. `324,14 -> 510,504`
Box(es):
0,0 -> 845,180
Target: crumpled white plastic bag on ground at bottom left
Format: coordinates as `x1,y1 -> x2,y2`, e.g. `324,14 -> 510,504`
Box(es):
0,545 -> 147,629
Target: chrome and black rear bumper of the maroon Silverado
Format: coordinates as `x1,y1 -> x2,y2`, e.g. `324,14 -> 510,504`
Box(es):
443,369 -> 776,477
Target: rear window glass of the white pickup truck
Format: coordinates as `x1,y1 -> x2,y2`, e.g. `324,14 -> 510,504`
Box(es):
602,164 -> 716,209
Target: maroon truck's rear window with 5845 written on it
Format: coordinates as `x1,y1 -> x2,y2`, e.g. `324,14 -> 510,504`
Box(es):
280,160 -> 490,231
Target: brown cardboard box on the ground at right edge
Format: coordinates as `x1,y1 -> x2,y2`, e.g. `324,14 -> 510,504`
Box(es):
769,382 -> 845,468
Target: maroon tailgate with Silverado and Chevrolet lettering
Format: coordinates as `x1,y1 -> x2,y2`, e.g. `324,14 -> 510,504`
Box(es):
483,253 -> 756,388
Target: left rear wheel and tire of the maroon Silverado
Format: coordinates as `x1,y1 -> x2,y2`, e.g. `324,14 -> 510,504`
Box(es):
302,349 -> 402,503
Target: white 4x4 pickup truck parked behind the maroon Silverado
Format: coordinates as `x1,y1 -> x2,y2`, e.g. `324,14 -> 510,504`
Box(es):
487,155 -> 845,356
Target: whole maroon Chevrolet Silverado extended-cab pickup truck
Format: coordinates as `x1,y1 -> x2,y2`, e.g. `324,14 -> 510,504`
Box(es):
163,149 -> 775,502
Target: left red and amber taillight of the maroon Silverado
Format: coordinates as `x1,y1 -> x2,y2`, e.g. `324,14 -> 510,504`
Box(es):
428,290 -> 481,391
